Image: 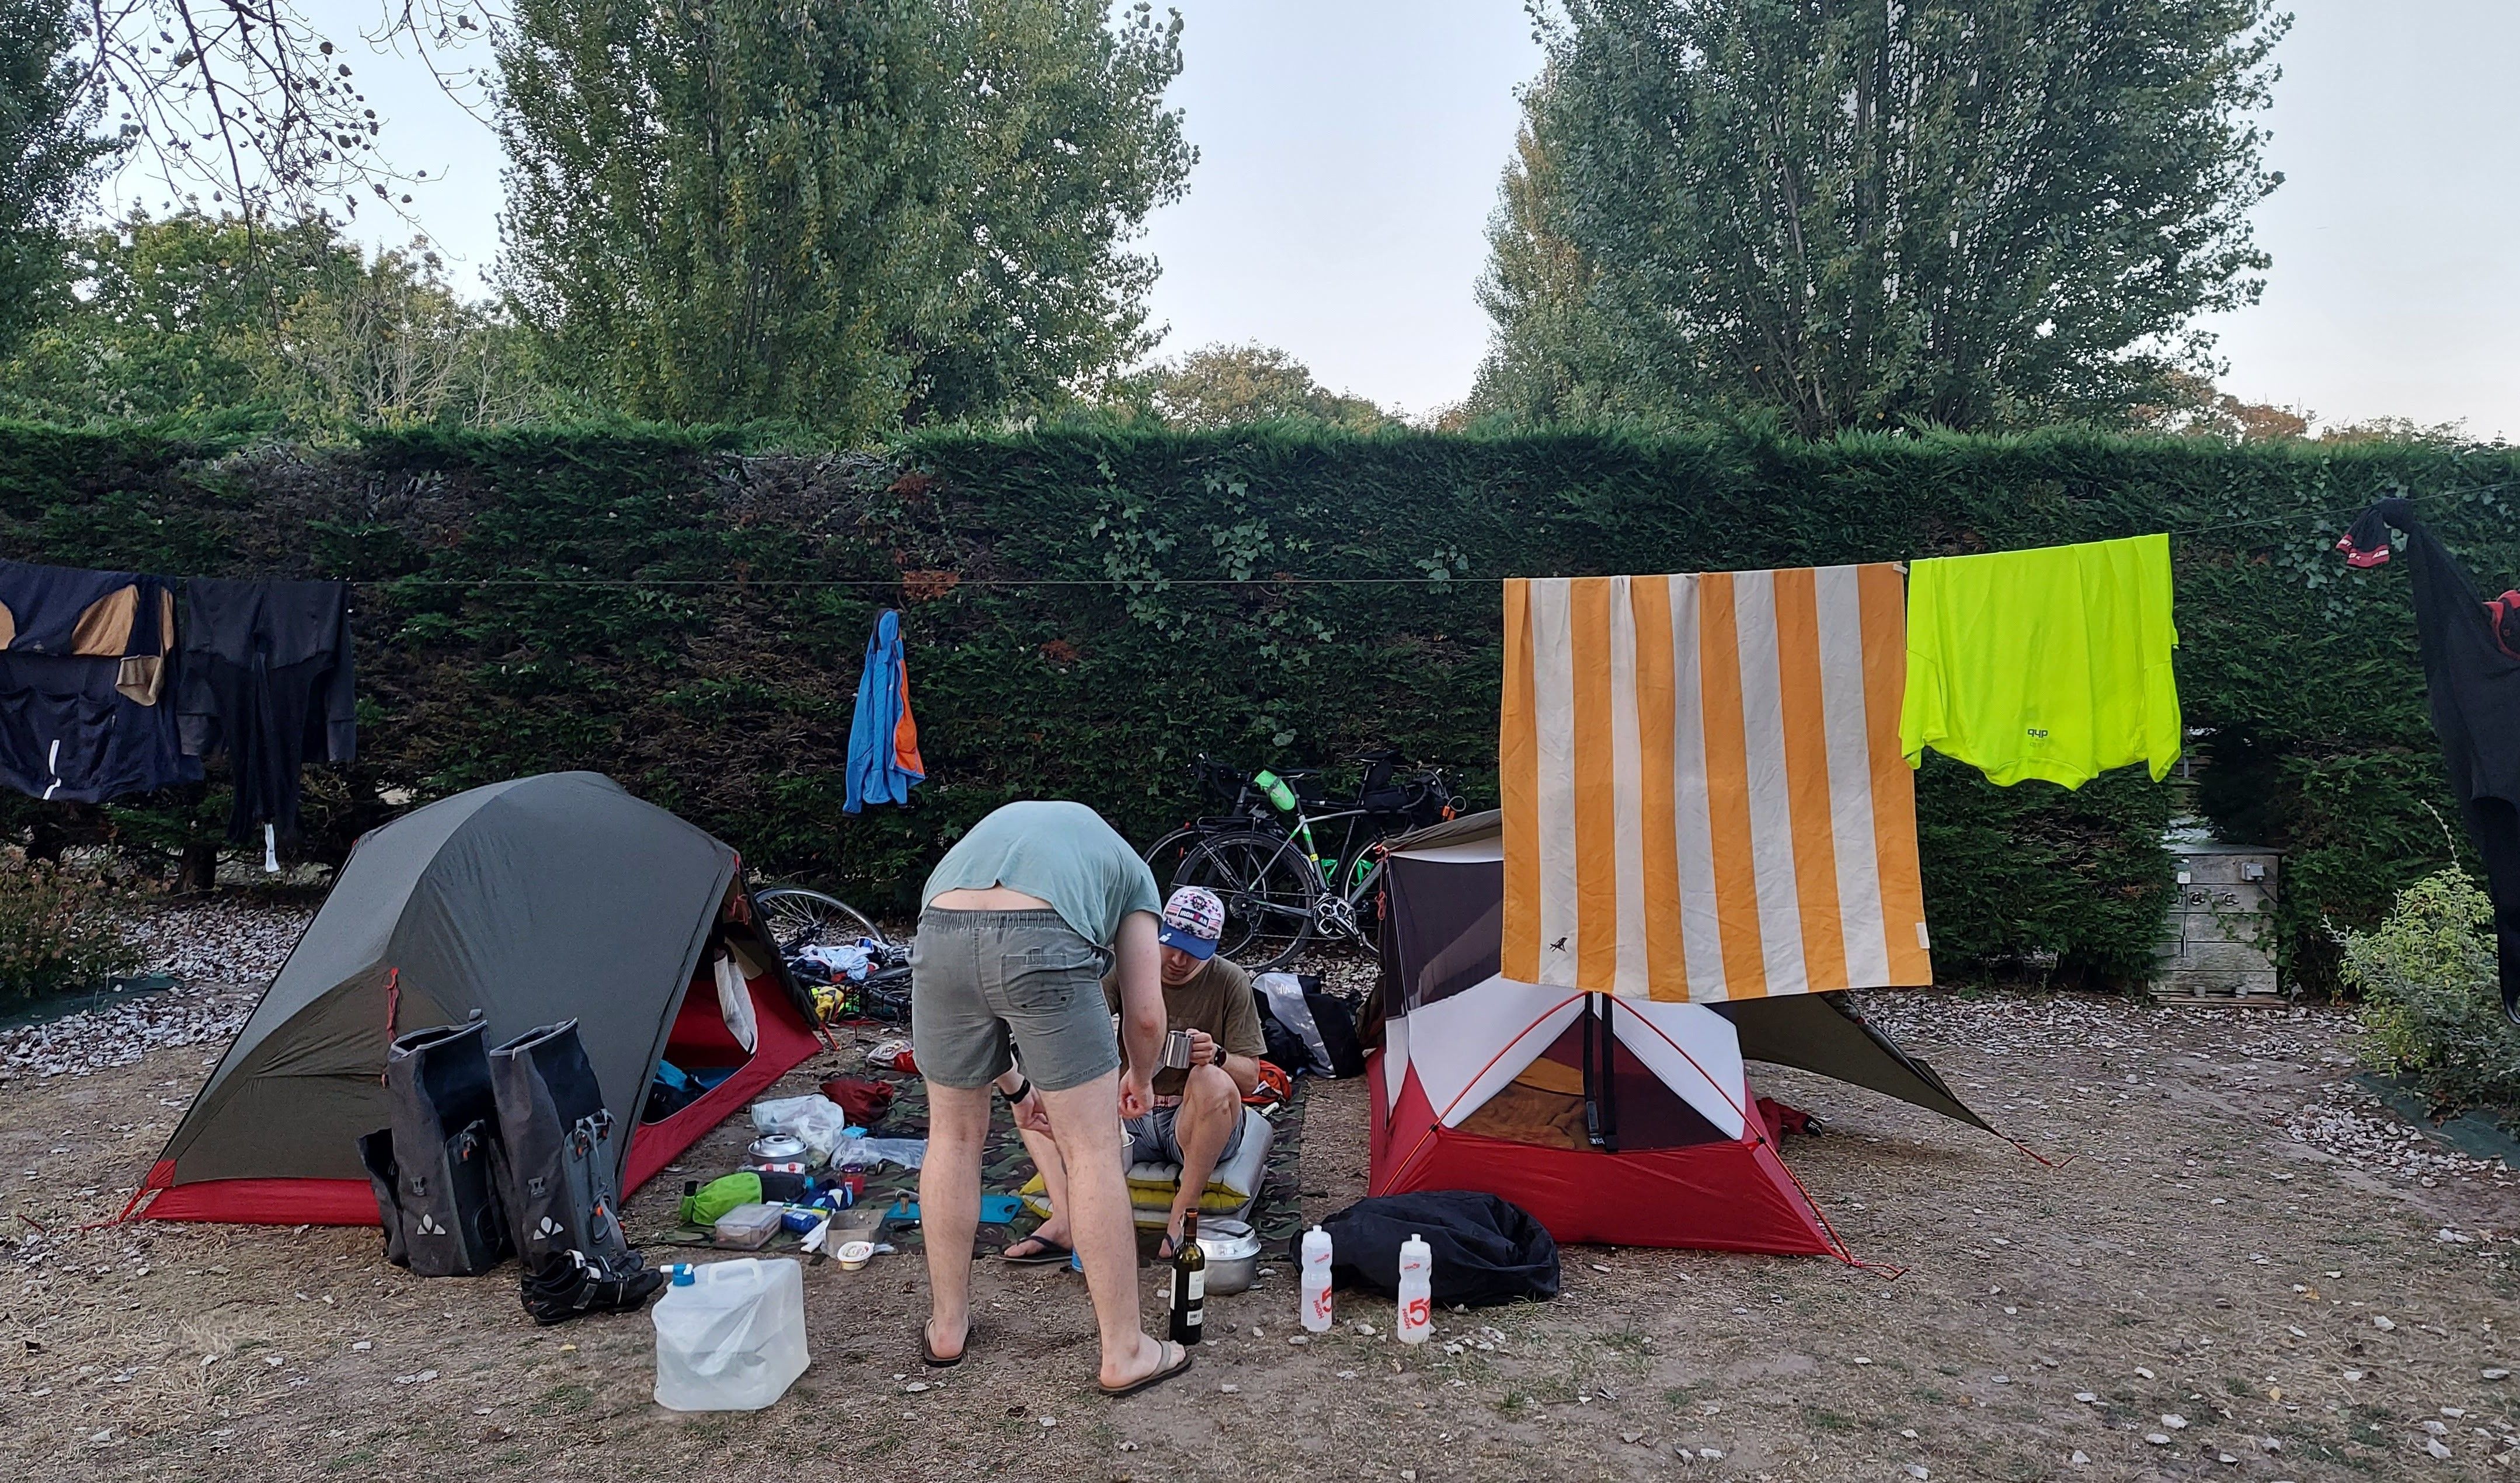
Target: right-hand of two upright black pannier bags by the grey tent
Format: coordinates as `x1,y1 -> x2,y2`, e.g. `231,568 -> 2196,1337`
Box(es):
489,1020 -> 665,1324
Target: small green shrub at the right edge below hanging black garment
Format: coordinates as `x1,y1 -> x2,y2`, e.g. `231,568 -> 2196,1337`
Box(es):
2341,869 -> 2520,1108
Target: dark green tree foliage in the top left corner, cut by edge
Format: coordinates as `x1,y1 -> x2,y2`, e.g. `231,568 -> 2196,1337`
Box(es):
0,0 -> 116,353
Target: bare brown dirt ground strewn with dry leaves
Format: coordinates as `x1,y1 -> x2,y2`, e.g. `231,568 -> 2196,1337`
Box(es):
0,931 -> 2520,1483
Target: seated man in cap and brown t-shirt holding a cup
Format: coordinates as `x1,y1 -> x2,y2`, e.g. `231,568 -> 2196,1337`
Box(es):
1003,886 -> 1268,1262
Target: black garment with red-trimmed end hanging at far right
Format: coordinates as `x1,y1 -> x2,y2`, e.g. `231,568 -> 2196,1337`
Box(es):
2336,499 -> 2520,1020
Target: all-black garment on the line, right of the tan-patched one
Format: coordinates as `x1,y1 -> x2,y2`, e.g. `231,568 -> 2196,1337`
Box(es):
176,577 -> 358,838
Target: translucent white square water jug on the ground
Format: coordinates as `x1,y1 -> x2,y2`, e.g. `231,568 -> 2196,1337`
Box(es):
650,1256 -> 806,1410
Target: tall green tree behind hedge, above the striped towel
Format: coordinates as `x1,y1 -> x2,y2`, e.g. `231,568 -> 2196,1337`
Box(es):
1477,0 -> 2288,436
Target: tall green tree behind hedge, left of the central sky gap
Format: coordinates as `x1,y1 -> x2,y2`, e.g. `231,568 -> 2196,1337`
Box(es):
499,0 -> 1195,436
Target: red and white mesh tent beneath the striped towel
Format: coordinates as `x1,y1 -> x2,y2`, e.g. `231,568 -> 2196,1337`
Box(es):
1366,813 -> 1986,1259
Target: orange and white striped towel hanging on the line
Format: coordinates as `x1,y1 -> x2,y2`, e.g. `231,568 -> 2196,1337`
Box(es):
1499,564 -> 1933,1002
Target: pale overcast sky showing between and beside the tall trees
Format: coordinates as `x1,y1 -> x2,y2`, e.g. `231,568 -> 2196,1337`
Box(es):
250,0 -> 2520,436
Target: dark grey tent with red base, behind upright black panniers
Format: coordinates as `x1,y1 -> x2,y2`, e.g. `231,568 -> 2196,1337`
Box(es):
136,773 -> 816,1226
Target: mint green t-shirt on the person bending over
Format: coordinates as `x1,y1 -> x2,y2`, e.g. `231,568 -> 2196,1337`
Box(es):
920,800 -> 1164,949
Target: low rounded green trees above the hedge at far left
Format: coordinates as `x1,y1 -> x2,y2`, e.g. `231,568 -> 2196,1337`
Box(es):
0,211 -> 549,430
